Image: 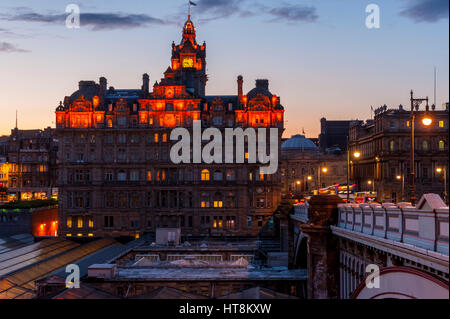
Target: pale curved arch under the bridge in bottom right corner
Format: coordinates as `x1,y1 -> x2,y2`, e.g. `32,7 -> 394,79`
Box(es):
351,266 -> 449,299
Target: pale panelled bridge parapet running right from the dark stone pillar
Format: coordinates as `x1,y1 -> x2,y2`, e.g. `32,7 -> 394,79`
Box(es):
337,203 -> 449,255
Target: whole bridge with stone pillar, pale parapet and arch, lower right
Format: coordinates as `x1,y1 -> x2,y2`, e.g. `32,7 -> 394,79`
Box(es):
290,194 -> 449,299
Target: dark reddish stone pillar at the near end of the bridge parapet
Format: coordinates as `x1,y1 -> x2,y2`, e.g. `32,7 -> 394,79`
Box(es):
300,195 -> 343,299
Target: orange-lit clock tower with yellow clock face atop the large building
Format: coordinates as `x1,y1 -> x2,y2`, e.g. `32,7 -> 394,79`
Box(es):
171,15 -> 207,97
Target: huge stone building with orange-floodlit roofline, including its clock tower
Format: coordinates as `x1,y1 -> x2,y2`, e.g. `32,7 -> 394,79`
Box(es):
55,17 -> 284,237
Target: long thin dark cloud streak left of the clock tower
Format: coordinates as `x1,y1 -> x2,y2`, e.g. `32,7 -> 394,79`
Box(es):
2,12 -> 166,31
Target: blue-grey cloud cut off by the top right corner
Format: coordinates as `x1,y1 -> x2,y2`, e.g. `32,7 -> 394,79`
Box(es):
400,0 -> 449,22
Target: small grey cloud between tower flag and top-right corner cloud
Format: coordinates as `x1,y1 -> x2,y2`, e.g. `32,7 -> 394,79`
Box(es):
266,5 -> 319,22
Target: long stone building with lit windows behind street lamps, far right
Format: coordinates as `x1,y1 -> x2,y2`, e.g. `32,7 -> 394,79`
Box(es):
350,105 -> 449,201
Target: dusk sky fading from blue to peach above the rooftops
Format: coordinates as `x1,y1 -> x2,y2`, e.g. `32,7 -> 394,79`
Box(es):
0,0 -> 449,137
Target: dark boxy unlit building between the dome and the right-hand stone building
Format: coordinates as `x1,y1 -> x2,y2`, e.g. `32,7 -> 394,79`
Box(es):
319,118 -> 360,151
